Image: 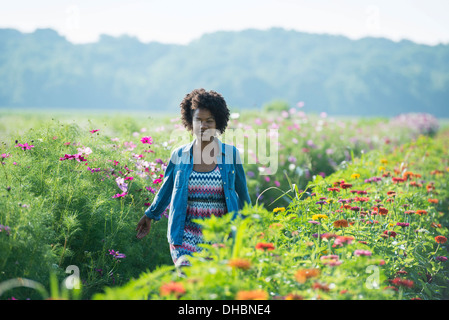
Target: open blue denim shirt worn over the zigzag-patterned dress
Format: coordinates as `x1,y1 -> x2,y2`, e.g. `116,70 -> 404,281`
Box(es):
145,138 -> 251,245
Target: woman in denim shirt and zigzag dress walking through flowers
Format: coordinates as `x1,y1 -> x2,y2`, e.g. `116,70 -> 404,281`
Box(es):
136,89 -> 251,266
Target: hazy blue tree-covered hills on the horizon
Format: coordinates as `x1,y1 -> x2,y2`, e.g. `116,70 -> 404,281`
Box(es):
0,28 -> 449,117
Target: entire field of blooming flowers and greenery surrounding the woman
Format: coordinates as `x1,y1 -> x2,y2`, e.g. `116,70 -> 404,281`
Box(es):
0,106 -> 449,300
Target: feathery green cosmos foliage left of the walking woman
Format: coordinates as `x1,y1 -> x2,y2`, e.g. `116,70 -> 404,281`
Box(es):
0,115 -> 171,299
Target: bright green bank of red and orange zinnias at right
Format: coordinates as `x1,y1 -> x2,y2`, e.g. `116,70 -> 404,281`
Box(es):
94,131 -> 449,300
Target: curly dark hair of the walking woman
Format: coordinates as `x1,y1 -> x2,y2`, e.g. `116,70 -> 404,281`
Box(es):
180,88 -> 230,134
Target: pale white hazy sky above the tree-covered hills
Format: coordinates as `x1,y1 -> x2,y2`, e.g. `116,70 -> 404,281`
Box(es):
0,0 -> 449,45
